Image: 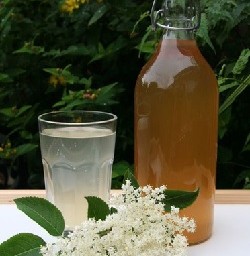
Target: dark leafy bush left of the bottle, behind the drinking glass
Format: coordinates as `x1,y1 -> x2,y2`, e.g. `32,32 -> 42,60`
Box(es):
0,0 -> 148,187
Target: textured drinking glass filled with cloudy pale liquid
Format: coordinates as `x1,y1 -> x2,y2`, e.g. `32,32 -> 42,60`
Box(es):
38,111 -> 117,230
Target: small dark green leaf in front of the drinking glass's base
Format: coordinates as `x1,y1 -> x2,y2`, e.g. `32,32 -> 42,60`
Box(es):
85,196 -> 111,220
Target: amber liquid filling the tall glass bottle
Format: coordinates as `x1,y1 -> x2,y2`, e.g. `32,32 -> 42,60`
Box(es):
135,39 -> 218,244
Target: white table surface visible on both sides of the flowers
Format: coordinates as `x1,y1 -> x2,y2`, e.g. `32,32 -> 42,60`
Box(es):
0,204 -> 250,256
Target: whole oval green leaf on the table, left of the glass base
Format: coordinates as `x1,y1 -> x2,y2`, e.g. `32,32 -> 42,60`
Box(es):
14,197 -> 65,236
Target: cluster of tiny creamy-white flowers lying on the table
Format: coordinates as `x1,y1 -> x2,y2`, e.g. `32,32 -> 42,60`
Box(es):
41,181 -> 195,256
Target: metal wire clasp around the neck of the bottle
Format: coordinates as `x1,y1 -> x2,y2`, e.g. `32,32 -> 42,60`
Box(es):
151,0 -> 201,30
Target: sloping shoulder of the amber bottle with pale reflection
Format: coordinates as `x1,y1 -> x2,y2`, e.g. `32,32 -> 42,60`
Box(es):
138,39 -> 216,86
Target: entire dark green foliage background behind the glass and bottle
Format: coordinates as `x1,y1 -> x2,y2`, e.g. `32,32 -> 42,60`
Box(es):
0,0 -> 250,188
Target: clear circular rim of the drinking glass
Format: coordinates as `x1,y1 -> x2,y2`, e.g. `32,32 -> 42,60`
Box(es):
38,110 -> 117,126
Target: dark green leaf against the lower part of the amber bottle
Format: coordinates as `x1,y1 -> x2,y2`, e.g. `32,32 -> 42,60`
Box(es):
163,189 -> 199,211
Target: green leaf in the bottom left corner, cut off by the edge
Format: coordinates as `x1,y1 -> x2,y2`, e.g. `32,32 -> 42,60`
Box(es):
0,233 -> 45,256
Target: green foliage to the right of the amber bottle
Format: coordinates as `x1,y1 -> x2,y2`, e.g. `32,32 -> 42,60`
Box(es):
197,0 -> 250,188
